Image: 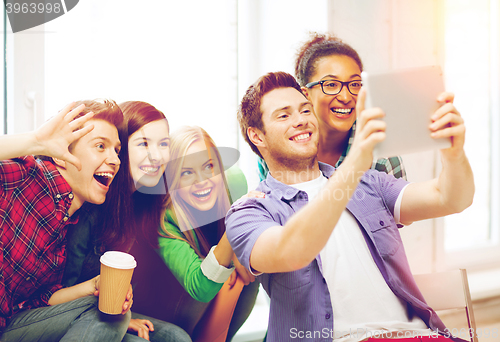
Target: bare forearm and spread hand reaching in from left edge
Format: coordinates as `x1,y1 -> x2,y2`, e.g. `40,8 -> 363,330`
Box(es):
0,104 -> 94,169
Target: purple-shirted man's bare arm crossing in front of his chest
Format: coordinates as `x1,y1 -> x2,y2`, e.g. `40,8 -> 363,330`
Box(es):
250,90 -> 386,273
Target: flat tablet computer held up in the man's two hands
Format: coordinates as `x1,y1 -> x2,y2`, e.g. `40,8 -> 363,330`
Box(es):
361,66 -> 451,159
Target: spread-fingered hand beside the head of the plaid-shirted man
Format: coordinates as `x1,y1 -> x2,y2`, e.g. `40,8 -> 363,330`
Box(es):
35,103 -> 94,170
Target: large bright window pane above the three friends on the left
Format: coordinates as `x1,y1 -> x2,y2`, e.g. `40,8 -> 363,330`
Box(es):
45,0 -> 237,147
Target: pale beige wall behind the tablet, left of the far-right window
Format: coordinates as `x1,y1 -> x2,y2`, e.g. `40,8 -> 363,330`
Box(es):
328,0 -> 442,273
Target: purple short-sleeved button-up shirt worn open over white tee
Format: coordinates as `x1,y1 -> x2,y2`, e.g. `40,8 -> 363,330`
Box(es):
226,163 -> 445,342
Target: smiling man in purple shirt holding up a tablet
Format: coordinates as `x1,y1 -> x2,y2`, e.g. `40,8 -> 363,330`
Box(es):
226,72 -> 474,342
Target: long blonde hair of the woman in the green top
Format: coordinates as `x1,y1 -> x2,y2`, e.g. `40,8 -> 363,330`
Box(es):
161,126 -> 231,257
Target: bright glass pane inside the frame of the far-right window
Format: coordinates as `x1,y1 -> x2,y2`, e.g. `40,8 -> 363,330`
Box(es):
445,0 -> 490,251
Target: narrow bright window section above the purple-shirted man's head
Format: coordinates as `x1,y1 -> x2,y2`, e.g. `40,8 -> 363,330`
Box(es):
238,0 -> 328,189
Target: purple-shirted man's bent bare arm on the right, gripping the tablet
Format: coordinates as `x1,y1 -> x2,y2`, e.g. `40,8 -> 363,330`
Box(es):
401,93 -> 474,224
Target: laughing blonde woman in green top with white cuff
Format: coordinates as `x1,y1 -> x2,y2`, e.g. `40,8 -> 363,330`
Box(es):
158,127 -> 258,341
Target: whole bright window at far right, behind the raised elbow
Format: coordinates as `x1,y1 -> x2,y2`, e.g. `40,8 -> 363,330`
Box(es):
440,0 -> 500,267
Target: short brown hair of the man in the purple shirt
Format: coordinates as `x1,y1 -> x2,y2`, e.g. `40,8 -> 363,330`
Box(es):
238,71 -> 302,158
